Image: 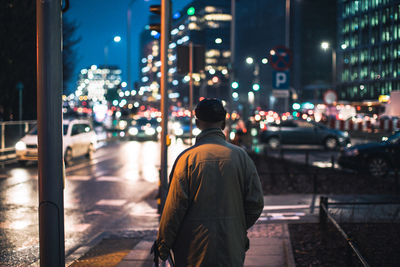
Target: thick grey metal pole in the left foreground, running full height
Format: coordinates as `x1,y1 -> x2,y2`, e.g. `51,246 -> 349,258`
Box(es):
36,0 -> 65,267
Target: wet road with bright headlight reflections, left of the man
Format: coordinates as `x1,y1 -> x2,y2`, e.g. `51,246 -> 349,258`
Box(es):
0,141 -> 187,266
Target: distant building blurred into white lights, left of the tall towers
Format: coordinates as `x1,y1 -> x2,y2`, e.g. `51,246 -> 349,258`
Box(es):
75,65 -> 122,102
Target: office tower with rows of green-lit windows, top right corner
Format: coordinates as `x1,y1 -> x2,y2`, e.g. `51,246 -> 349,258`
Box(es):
337,0 -> 400,101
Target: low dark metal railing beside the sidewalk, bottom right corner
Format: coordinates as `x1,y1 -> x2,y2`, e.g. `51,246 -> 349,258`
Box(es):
319,196 -> 400,267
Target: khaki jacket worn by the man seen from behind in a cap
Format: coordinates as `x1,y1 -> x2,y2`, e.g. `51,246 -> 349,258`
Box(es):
157,128 -> 264,267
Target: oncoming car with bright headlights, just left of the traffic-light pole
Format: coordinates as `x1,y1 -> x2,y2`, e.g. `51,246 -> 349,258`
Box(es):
128,117 -> 161,141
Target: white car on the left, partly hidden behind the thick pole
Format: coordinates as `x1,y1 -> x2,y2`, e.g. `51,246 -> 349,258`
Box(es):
15,119 -> 97,165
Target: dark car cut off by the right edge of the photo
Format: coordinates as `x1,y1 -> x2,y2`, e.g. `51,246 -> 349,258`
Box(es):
338,132 -> 400,177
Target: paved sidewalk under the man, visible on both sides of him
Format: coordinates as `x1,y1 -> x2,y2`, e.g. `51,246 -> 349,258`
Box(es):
117,223 -> 295,267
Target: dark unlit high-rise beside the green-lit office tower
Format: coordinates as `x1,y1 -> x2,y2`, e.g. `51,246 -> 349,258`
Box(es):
290,0 -> 338,103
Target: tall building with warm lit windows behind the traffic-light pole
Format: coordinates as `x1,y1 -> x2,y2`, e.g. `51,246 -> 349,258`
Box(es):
139,0 -> 232,106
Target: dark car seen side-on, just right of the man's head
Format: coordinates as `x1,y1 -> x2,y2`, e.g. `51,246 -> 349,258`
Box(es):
260,120 -> 350,150
